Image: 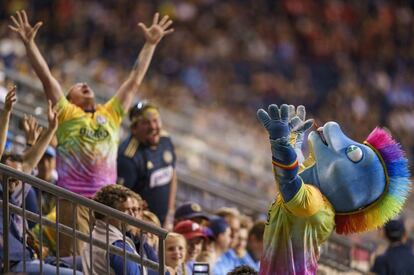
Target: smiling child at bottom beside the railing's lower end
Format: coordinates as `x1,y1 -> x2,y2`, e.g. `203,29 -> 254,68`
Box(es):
165,232 -> 191,275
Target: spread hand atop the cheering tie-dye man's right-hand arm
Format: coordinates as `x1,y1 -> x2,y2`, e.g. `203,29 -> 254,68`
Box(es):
138,12 -> 174,44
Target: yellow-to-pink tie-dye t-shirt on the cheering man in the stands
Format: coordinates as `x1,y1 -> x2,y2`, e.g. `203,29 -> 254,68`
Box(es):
56,97 -> 124,198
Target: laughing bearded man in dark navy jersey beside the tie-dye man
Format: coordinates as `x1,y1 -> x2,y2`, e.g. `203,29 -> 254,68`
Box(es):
118,102 -> 177,230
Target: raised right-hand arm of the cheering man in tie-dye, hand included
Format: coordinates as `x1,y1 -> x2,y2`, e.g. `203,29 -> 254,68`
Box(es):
115,13 -> 174,110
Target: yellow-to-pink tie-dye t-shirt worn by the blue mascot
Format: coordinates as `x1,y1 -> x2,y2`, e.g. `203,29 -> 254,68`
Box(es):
260,183 -> 335,275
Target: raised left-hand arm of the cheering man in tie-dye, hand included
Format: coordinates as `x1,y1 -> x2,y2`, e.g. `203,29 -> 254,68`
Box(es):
9,10 -> 63,105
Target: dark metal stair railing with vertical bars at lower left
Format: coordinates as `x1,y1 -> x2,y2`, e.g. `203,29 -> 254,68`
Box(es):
0,164 -> 168,274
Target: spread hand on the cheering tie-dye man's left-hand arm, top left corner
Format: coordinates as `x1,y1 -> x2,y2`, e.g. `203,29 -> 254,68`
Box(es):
9,10 -> 43,44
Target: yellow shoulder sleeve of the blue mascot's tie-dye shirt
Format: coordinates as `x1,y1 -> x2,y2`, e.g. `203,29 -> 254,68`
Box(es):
284,184 -> 324,217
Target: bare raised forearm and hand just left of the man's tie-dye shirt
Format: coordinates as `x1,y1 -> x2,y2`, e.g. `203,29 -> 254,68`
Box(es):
23,100 -> 58,173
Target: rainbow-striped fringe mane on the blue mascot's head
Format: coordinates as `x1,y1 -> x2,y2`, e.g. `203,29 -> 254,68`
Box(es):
335,127 -> 411,234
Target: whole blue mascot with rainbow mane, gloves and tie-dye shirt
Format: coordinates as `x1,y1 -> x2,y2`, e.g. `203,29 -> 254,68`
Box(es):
258,104 -> 411,275
